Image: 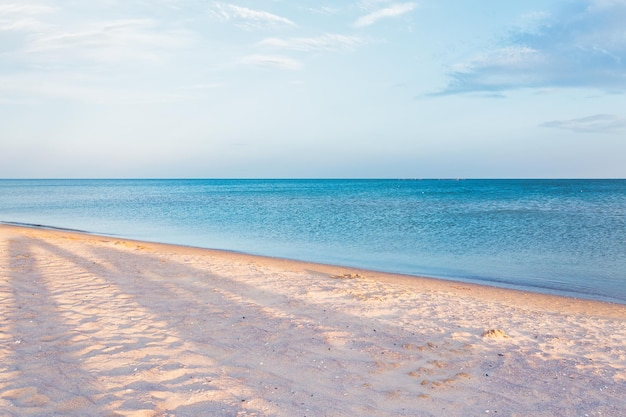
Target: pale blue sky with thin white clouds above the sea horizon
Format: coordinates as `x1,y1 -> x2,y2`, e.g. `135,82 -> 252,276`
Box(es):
0,0 -> 626,178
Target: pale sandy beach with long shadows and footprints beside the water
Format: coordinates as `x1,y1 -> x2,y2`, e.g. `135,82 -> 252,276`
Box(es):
0,226 -> 626,416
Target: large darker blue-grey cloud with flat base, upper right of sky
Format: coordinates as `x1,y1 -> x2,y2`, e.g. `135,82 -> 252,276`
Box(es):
438,0 -> 626,94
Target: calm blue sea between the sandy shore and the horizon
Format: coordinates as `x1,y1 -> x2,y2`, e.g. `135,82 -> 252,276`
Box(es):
0,180 -> 626,304
